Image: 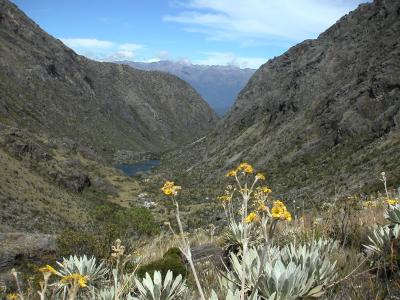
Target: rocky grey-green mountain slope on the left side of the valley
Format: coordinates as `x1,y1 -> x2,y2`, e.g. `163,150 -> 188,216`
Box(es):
0,0 -> 217,159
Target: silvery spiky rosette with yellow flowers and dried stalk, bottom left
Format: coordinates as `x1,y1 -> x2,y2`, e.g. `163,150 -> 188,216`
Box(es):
34,240 -> 141,300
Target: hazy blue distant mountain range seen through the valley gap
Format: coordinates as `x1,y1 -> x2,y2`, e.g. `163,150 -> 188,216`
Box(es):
118,60 -> 256,116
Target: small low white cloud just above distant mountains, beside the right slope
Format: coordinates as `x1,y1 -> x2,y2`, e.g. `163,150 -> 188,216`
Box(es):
194,52 -> 267,69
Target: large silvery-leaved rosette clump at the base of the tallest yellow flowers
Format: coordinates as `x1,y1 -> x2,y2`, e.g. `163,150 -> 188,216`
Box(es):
225,240 -> 337,299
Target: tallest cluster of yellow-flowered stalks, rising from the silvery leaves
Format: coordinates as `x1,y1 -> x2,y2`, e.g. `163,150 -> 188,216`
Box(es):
218,163 -> 292,300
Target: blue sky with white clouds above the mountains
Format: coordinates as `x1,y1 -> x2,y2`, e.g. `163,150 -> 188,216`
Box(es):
13,0 -> 366,68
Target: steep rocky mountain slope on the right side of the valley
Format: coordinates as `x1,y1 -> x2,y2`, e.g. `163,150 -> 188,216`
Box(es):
167,0 -> 400,200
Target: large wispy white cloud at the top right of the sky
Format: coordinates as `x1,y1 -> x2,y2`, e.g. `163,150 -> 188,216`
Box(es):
163,0 -> 366,45
